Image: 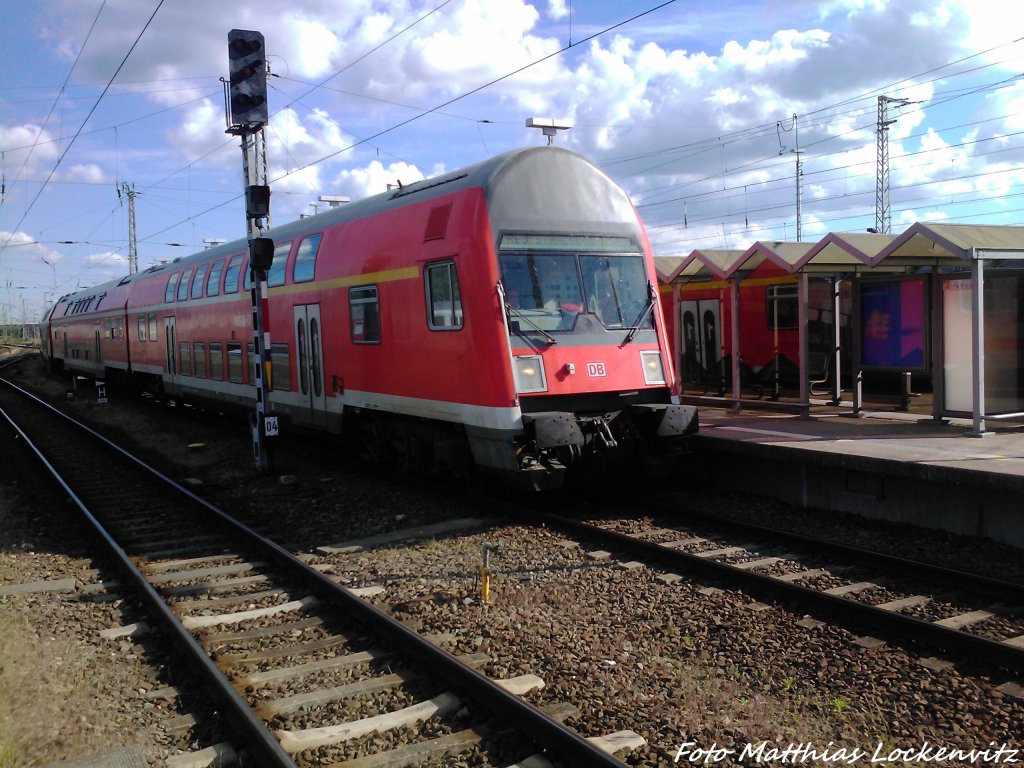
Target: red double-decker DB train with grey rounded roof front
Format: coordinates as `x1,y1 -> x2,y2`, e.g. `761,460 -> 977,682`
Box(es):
39,147 -> 696,488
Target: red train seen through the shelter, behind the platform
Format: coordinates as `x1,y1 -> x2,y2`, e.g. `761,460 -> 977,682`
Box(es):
660,261 -> 851,395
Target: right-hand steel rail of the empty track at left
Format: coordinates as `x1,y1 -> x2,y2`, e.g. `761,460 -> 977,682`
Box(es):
0,379 -> 626,768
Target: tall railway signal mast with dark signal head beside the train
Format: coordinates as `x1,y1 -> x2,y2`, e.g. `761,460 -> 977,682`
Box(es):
225,30 -> 278,472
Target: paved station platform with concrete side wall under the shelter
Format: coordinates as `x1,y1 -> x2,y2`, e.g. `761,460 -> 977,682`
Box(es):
685,401 -> 1024,548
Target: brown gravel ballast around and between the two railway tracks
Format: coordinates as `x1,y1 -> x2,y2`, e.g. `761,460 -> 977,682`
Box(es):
0,361 -> 1024,766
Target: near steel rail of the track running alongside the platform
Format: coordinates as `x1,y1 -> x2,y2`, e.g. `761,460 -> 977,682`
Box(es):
531,512 -> 1024,674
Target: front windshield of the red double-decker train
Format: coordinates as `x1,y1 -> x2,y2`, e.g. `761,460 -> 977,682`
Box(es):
499,244 -> 652,333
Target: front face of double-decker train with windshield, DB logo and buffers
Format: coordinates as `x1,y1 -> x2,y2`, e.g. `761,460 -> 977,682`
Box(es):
499,238 -> 697,487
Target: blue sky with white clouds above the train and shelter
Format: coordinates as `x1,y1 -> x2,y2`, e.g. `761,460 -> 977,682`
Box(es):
0,0 -> 1024,322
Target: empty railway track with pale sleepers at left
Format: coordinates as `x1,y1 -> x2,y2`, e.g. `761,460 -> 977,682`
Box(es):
0,381 -> 623,766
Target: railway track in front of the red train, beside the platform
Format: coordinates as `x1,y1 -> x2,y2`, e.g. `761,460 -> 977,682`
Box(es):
531,503 -> 1024,691
